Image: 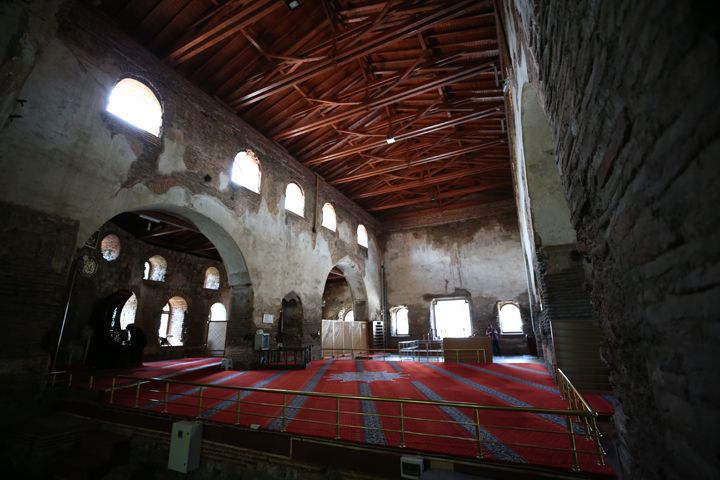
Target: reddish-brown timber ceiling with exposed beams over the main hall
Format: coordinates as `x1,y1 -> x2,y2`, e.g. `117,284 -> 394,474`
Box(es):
99,0 -> 513,222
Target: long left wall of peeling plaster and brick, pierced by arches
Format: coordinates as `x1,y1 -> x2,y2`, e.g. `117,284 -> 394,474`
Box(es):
0,1 -> 380,394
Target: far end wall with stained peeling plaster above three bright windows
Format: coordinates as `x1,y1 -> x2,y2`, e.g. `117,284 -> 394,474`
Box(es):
384,205 -> 532,354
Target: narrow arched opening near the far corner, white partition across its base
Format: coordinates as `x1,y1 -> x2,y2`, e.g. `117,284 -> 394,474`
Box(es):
321,258 -> 368,356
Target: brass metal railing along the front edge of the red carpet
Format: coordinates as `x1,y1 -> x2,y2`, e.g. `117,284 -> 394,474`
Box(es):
49,371 -> 605,471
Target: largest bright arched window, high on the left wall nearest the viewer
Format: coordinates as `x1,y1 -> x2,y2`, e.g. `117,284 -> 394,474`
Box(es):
107,78 -> 162,137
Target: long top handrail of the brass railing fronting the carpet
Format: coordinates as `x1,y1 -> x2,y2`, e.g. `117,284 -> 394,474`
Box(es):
60,372 -> 597,417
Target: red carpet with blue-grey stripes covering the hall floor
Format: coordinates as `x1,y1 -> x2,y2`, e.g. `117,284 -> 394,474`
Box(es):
71,359 -> 613,475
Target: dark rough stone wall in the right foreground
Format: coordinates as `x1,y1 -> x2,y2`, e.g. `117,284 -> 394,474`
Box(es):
503,0 -> 720,479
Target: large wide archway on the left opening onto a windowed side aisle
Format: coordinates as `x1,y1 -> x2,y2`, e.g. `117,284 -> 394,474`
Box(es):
60,205 -> 252,368
